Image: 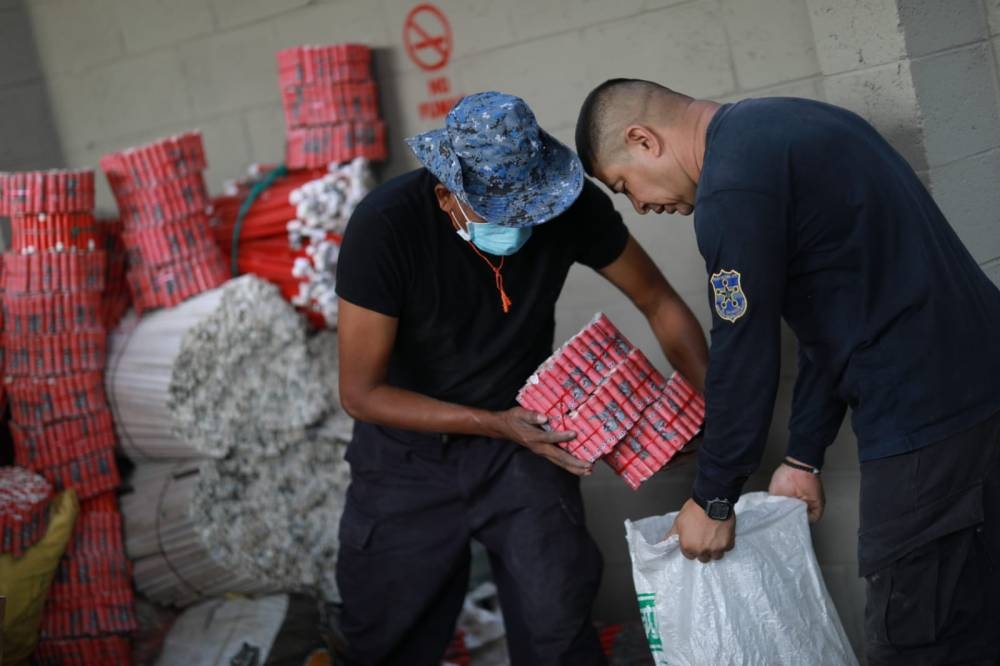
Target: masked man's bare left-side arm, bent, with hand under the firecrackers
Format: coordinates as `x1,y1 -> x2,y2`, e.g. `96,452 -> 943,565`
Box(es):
337,299 -> 591,476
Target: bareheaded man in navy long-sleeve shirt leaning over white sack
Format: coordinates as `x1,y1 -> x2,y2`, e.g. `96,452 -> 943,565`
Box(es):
576,79 -> 1000,664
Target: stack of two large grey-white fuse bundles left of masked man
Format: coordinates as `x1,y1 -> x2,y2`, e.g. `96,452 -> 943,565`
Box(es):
114,276 -> 353,606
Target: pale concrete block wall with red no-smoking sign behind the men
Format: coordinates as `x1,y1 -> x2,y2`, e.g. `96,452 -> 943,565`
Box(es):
21,0 -> 1000,645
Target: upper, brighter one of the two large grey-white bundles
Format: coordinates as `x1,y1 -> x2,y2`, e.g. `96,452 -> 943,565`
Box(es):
107,275 -> 339,461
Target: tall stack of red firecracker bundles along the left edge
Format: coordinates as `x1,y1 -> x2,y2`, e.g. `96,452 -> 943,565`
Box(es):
0,171 -> 135,663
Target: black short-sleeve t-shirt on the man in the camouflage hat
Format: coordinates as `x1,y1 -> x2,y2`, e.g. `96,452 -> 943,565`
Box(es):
337,169 -> 628,409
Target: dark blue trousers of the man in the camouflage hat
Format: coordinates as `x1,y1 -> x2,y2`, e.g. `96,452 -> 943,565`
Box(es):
337,422 -> 606,666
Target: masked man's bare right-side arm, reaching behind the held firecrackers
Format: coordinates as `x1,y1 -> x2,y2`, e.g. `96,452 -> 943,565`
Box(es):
600,236 -> 708,391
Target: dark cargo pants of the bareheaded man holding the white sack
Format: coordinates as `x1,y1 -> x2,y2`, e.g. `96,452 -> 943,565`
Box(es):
859,416 -> 1000,666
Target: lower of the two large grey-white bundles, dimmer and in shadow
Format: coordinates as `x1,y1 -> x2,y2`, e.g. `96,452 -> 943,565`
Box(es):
122,427 -> 349,607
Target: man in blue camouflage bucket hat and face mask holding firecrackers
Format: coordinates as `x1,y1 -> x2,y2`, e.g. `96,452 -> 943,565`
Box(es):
337,92 -> 707,666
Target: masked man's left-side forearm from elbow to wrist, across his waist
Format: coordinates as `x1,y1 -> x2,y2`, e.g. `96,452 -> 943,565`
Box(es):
341,384 -> 502,437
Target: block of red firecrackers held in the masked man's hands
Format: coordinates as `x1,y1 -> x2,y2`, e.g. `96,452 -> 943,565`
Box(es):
517,314 -> 705,490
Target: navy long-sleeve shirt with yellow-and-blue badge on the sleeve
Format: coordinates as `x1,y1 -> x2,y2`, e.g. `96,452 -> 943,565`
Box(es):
695,98 -> 1000,501
